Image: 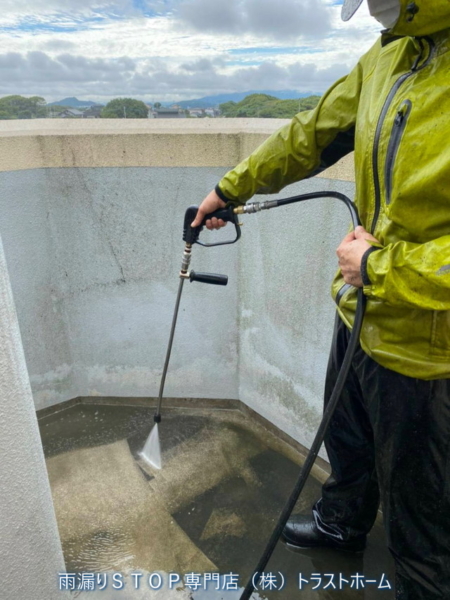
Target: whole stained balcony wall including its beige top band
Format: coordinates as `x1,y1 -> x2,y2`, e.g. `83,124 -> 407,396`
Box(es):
0,119 -> 353,443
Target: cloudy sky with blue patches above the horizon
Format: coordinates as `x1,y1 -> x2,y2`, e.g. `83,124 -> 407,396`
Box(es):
0,0 -> 380,103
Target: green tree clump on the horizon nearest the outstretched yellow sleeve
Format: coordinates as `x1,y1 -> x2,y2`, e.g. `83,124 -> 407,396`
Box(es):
220,94 -> 320,119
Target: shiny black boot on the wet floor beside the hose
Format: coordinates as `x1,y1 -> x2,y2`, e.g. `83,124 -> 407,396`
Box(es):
282,515 -> 366,552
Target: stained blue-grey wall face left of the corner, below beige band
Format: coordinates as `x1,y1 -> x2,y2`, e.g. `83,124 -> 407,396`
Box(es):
0,167 -> 238,408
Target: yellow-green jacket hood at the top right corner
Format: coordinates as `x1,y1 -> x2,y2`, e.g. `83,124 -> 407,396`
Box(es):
388,0 -> 450,37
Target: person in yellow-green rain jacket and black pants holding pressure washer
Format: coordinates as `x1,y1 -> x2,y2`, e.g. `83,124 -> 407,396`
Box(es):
193,0 -> 450,600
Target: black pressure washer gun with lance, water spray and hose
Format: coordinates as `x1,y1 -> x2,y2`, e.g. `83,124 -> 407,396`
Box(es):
141,191 -> 365,600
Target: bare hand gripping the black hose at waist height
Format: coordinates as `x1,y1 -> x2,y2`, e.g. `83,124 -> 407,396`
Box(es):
336,226 -> 379,287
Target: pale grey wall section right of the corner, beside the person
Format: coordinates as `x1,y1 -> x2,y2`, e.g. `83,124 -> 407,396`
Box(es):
238,178 -> 354,447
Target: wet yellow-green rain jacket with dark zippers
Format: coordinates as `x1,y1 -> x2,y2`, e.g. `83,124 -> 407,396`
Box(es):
217,0 -> 450,379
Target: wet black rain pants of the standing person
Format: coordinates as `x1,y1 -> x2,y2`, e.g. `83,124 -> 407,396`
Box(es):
314,317 -> 450,600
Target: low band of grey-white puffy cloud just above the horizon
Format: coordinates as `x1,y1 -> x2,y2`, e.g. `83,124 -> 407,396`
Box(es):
0,52 -> 352,100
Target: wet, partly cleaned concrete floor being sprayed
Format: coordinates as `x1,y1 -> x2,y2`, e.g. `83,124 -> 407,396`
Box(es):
40,404 -> 394,600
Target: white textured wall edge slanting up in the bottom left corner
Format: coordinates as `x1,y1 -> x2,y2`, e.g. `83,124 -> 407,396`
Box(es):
0,236 -> 64,600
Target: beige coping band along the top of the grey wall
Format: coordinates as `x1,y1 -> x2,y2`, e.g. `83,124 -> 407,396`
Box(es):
0,119 -> 354,181
